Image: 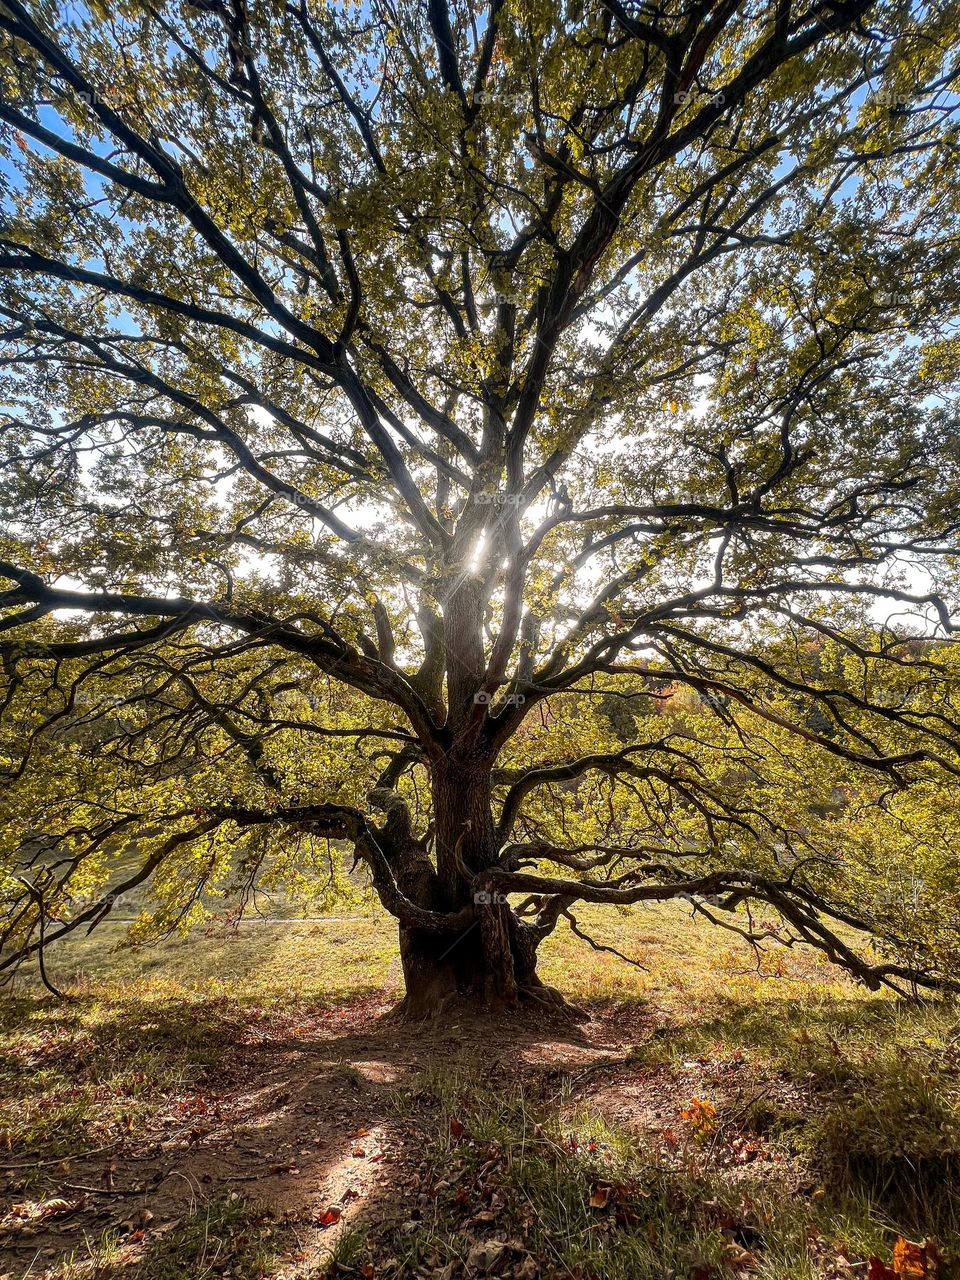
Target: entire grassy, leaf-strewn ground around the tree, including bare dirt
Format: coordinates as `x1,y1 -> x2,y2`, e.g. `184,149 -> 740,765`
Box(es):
0,906 -> 960,1280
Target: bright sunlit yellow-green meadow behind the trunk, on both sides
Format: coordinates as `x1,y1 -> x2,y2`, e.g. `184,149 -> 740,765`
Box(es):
5,904 -> 859,1014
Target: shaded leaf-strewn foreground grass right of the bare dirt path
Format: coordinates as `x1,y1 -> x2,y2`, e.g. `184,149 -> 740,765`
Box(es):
360,1068 -> 960,1280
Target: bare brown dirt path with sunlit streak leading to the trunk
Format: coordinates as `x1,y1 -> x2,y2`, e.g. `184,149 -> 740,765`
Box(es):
0,1001 -> 798,1280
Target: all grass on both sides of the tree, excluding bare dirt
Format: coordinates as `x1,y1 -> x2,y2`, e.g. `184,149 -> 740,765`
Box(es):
0,905 -> 960,1280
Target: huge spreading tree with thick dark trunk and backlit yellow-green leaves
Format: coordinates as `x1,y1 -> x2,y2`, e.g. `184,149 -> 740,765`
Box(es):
0,0 -> 960,1015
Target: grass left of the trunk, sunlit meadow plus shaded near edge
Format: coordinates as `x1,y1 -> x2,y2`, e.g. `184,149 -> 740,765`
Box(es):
0,916 -> 399,1183
